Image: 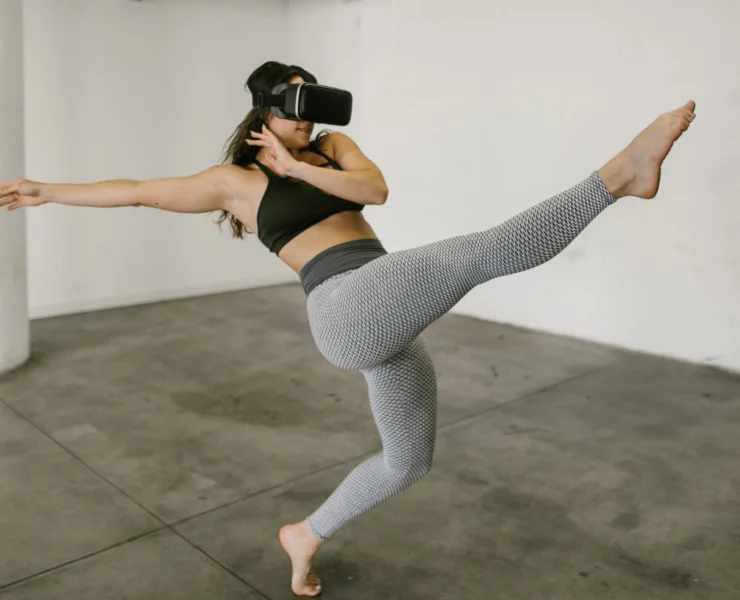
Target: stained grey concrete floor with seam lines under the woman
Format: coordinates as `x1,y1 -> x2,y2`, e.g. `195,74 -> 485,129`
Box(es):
0,284 -> 740,600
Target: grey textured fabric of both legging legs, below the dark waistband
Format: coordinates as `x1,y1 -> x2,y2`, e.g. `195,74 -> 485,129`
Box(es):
306,172 -> 615,541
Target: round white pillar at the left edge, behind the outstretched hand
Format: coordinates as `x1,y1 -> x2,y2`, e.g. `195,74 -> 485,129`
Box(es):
0,0 -> 30,373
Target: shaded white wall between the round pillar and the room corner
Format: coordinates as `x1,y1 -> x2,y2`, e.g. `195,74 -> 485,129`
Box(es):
24,0 -> 297,318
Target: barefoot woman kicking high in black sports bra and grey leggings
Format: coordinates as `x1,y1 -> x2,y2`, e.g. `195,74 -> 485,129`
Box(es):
0,62 -> 695,596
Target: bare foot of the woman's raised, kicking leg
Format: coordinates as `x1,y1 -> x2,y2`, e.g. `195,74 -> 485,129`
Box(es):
598,100 -> 696,200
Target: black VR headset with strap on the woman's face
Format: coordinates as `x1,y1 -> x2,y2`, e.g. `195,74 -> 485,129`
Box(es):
252,83 -> 352,125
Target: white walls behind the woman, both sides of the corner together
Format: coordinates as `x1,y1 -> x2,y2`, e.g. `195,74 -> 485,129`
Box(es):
24,0 -> 740,370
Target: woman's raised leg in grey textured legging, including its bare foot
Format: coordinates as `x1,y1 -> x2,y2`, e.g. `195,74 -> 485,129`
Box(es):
308,102 -> 695,369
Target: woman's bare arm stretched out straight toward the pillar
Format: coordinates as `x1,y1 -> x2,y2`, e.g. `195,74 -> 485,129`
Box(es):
0,165 -> 247,213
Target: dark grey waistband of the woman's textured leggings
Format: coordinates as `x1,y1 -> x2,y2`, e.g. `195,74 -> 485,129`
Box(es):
299,238 -> 388,297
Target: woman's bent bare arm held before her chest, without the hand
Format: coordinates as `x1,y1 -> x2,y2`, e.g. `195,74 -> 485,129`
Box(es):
288,132 -> 388,204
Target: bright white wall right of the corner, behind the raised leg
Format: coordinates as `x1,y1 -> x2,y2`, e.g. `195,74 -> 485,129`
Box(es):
291,0 -> 740,370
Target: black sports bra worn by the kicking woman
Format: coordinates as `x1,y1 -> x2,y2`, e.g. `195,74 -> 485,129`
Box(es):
254,150 -> 365,254
